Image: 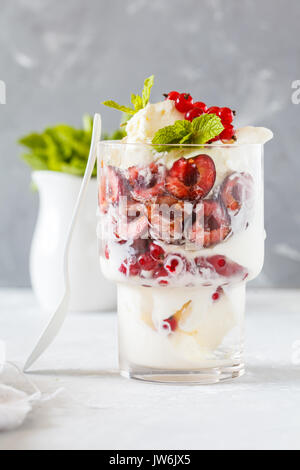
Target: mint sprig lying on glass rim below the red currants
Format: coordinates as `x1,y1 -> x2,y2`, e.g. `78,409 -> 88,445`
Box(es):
152,114 -> 224,152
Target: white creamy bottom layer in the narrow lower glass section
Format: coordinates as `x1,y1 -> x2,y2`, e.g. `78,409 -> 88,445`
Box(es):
118,284 -> 245,369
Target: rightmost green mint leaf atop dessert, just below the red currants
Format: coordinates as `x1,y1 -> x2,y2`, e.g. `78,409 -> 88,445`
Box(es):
192,114 -> 224,144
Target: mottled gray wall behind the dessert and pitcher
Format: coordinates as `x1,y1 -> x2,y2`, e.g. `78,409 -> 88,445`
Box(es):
0,0 -> 300,287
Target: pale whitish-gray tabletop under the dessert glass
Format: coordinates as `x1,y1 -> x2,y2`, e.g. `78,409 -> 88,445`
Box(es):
0,289 -> 300,450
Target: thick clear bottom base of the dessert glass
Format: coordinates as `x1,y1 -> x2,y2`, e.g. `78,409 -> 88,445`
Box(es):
120,363 -> 245,385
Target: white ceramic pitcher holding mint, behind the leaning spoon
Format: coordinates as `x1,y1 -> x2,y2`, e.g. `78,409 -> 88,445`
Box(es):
30,171 -> 116,311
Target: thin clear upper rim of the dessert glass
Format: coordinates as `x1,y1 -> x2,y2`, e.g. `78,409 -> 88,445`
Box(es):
98,140 -> 265,149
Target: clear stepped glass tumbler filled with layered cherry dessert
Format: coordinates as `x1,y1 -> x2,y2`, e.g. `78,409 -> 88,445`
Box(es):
97,141 -> 265,384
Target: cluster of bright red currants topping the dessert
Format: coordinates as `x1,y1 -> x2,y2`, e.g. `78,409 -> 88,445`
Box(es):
165,91 -> 235,142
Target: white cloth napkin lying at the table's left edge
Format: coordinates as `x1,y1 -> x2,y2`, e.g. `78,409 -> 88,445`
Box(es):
0,341 -> 62,432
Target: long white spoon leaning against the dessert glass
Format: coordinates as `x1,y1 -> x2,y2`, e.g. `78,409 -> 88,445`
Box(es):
24,114 -> 101,371
